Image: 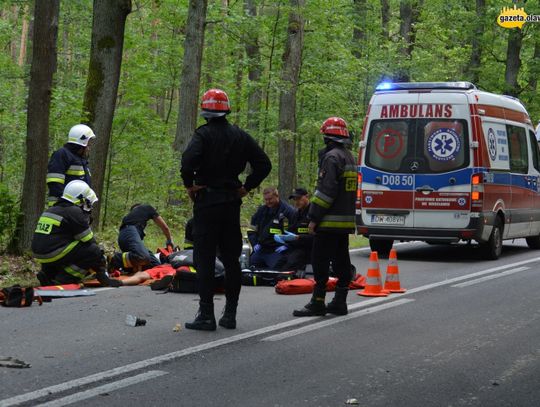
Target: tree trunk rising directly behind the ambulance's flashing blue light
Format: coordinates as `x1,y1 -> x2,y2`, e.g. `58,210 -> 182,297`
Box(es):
394,0 -> 419,82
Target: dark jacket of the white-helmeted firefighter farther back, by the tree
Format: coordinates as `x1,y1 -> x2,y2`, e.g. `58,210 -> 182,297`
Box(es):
47,143 -> 92,205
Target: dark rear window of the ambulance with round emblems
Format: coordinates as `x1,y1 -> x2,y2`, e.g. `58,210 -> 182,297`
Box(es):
366,119 -> 469,173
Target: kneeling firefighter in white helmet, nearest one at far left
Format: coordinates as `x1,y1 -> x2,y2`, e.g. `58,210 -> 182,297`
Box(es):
32,180 -> 122,287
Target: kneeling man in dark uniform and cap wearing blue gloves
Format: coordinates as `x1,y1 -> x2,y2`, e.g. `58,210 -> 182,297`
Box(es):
274,188 -> 313,271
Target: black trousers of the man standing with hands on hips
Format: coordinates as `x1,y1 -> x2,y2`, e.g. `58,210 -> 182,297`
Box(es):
193,190 -> 242,304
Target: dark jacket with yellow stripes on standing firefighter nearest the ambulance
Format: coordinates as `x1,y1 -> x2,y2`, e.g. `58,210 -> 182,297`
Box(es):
309,143 -> 357,233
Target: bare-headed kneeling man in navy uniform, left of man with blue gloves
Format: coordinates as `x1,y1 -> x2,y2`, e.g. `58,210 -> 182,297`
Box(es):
248,187 -> 295,270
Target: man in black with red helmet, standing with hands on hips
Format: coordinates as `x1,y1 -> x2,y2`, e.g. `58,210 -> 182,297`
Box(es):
180,89 -> 272,331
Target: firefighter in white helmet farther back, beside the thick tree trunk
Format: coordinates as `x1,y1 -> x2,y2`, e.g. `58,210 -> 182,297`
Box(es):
47,124 -> 96,206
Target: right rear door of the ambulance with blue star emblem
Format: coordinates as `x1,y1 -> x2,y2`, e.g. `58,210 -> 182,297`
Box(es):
409,92 -> 472,229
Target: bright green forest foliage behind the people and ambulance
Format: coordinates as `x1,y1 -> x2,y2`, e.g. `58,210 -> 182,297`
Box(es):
0,0 -> 540,253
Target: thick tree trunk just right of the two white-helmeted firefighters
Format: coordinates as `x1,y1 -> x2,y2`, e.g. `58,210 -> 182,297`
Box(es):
83,0 -> 131,228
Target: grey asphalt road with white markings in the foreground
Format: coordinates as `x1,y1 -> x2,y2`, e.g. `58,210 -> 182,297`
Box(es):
0,240 -> 540,407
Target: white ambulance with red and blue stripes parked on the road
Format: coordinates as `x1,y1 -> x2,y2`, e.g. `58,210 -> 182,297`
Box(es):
356,82 -> 540,259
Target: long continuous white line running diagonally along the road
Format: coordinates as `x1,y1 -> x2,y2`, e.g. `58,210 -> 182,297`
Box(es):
4,257 -> 540,407
